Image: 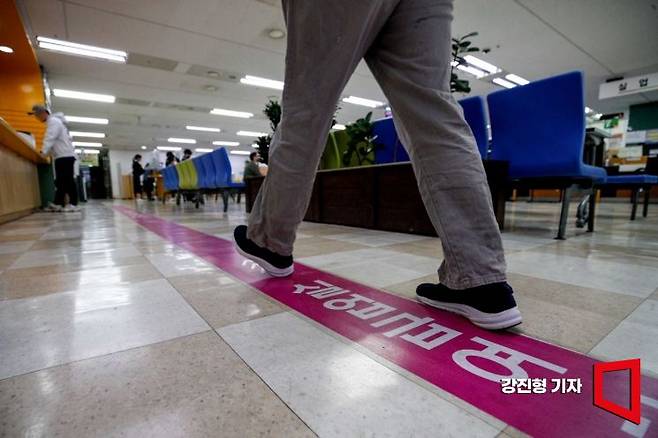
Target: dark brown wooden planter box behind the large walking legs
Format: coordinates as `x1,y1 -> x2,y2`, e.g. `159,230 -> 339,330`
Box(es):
245,160 -> 508,236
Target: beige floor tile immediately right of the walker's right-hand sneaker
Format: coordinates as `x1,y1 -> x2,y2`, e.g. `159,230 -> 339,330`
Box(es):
508,274 -> 642,353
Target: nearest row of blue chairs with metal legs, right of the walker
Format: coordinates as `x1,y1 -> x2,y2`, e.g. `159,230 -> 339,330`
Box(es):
375,71 -> 658,239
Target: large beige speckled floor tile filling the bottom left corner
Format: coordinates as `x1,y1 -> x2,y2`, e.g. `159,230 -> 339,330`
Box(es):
0,332 -> 313,437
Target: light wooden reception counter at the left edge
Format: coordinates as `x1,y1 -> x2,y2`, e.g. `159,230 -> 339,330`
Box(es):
0,119 -> 48,223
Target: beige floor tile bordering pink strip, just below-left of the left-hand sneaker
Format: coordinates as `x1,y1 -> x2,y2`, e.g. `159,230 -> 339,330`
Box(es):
169,272 -> 284,328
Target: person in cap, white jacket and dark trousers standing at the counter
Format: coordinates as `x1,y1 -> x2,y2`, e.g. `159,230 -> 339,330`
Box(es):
28,105 -> 79,212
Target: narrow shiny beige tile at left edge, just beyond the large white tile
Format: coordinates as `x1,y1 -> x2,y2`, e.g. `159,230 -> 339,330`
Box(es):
0,264 -> 162,300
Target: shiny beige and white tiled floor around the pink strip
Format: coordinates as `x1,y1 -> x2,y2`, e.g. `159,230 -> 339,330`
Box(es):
0,198 -> 658,437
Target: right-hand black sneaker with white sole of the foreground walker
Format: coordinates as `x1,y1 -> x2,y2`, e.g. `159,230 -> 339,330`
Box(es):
416,282 -> 522,330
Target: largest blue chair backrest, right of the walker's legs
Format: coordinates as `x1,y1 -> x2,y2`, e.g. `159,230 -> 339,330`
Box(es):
487,72 -> 585,178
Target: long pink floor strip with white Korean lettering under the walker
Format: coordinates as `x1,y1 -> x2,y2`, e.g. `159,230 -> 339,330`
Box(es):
115,206 -> 658,437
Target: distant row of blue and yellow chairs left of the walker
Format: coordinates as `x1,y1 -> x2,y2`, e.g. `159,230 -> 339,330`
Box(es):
161,148 -> 244,211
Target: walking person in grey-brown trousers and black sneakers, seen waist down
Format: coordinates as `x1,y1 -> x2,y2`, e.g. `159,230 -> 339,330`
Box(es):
234,0 -> 521,329
